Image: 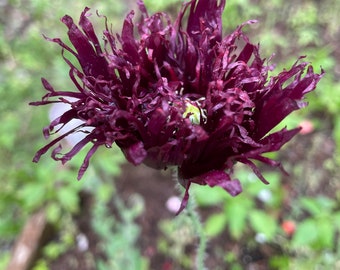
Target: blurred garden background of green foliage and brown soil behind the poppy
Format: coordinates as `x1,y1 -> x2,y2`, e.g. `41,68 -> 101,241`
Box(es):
0,0 -> 340,270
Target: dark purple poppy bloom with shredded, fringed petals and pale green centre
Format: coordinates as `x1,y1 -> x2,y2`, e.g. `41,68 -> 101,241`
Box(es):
31,0 -> 323,210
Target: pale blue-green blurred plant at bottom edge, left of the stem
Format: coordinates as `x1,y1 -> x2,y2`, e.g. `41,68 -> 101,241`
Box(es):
92,193 -> 149,270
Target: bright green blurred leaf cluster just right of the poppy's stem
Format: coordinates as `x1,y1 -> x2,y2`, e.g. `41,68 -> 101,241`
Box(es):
194,167 -> 283,241
